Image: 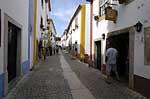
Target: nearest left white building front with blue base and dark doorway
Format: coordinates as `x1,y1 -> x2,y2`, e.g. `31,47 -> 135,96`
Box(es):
0,0 -> 29,99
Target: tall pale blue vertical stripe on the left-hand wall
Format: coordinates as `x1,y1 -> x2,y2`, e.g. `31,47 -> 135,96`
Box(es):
28,0 -> 32,68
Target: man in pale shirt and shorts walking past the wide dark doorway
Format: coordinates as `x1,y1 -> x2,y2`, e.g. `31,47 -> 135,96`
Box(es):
105,44 -> 119,83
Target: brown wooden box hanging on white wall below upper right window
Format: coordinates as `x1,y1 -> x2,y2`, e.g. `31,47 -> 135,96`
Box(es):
105,6 -> 118,22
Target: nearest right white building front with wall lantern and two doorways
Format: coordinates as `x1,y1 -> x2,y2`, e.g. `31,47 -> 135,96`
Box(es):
92,0 -> 150,97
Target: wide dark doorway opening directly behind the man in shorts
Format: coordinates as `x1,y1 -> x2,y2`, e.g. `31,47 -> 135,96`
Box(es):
110,32 -> 129,82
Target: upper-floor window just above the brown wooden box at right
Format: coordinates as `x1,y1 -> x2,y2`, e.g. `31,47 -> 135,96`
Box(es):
99,0 -> 110,16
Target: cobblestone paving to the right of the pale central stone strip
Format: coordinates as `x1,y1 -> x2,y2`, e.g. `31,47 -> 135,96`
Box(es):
64,50 -> 147,99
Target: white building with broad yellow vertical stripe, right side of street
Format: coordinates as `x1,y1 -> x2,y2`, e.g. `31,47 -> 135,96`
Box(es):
66,4 -> 90,59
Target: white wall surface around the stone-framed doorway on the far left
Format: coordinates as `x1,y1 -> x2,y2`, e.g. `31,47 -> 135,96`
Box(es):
0,0 -> 28,73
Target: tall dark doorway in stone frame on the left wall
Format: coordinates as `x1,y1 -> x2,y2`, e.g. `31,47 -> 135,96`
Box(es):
7,22 -> 21,83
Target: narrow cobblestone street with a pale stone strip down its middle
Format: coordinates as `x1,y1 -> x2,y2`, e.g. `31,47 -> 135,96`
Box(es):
6,51 -> 147,99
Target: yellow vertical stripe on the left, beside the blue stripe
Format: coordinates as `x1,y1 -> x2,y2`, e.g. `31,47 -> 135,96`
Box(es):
33,0 -> 37,65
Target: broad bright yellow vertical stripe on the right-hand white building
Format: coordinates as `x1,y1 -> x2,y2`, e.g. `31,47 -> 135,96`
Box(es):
80,5 -> 86,59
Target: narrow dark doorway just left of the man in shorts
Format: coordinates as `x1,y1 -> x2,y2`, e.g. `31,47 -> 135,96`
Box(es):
95,41 -> 101,70
